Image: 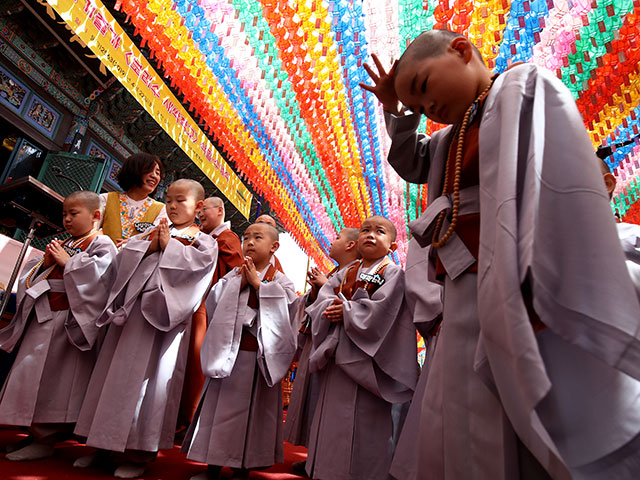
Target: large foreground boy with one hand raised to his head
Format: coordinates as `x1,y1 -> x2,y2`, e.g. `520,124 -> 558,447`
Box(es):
365,31 -> 640,479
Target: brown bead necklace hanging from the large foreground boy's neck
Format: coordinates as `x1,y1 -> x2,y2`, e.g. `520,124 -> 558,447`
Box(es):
431,80 -> 493,248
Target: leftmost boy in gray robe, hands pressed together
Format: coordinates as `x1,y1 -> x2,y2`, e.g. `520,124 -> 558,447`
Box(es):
0,191 -> 116,460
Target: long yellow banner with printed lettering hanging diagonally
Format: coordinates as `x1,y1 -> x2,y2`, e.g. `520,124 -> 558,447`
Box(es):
47,0 -> 252,219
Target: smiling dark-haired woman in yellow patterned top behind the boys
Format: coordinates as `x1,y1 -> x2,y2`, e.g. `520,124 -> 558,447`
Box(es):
100,153 -> 167,246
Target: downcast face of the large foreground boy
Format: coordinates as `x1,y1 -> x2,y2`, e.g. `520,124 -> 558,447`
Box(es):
394,39 -> 479,123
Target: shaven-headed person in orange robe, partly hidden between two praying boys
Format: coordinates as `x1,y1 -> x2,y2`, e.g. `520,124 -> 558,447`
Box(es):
176,197 -> 244,430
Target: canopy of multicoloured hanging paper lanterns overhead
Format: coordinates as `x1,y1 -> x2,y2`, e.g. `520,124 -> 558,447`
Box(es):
49,0 -> 640,266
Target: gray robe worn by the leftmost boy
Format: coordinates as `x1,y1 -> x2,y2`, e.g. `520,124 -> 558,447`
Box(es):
0,235 -> 116,426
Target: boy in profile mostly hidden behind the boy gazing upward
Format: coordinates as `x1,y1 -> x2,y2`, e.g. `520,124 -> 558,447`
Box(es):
284,228 -> 360,456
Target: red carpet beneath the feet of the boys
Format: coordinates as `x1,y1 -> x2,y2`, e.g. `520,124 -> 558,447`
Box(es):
0,430 -> 306,480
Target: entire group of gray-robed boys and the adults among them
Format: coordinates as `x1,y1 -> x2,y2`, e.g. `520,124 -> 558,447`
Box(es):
0,31 -> 640,480
